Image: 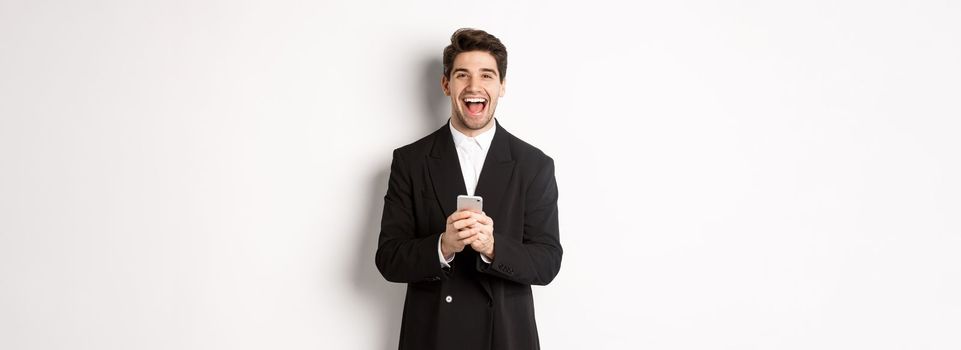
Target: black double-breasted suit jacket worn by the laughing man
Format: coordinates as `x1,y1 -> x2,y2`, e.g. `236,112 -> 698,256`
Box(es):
375,121 -> 562,350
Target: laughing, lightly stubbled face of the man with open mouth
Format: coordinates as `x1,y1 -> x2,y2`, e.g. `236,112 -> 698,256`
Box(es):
441,51 -> 504,136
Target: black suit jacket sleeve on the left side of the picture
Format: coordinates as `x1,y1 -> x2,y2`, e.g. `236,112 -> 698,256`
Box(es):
374,150 -> 446,283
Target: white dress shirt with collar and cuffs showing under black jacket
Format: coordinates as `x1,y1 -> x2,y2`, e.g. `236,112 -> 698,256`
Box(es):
437,123 -> 497,267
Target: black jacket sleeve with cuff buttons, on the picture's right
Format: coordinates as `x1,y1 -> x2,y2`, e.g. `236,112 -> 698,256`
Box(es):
477,157 -> 563,285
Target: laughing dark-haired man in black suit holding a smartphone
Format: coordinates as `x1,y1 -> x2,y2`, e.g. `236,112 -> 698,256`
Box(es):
376,29 -> 562,350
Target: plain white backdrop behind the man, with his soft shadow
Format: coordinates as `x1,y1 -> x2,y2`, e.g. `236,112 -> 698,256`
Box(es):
0,0 -> 961,350
